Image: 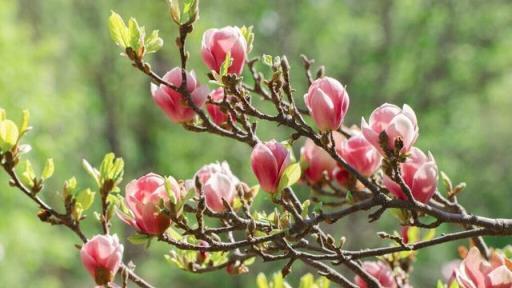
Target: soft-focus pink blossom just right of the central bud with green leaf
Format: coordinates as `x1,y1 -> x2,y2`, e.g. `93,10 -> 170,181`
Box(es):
300,139 -> 336,184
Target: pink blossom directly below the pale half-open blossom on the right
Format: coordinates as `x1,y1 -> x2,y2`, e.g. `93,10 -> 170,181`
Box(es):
384,147 -> 438,203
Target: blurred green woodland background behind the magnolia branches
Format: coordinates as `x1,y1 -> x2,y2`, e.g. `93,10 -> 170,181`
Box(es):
0,0 -> 512,288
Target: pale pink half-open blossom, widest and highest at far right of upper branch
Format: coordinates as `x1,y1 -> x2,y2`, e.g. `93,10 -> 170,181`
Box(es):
361,103 -> 419,156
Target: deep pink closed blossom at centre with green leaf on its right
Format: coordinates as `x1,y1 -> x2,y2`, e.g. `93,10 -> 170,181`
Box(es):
251,140 -> 291,193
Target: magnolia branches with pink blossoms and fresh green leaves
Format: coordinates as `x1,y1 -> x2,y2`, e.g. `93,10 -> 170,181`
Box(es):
0,0 -> 512,288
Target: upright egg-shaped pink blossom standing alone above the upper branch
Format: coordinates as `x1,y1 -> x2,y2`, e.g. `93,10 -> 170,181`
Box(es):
304,77 -> 350,131
